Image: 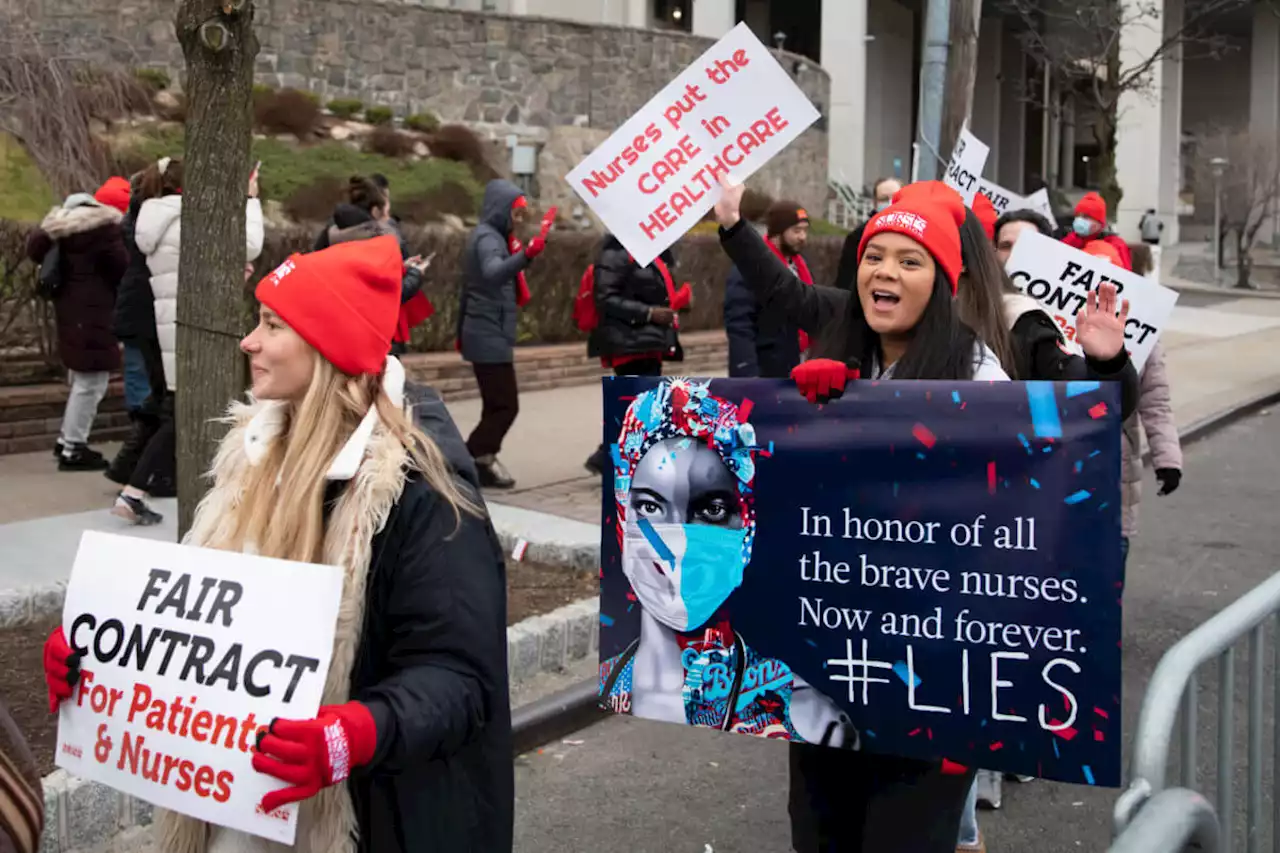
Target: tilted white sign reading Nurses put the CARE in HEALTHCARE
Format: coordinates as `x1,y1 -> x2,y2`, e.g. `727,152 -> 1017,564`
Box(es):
567,23 -> 819,265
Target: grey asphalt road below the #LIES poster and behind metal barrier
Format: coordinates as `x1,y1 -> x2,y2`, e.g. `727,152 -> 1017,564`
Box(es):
516,412 -> 1280,853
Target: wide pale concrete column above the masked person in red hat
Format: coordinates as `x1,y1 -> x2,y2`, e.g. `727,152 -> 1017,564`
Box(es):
1111,0 -> 1183,243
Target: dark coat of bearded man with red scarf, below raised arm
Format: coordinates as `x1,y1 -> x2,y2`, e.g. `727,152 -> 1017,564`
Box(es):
724,266 -> 800,379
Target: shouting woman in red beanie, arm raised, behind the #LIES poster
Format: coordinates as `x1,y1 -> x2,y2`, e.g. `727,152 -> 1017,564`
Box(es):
716,179 -> 1007,853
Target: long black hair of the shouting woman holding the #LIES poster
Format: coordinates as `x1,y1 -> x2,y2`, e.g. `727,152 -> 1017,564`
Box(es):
814,266 -> 978,379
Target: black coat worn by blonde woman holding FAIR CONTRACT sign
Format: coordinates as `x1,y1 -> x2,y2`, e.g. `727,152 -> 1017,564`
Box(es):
348,475 -> 515,853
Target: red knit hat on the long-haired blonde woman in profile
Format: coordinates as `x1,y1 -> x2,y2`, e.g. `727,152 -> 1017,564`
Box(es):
255,234 -> 404,377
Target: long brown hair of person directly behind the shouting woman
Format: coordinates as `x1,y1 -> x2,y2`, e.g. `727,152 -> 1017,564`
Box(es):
956,207 -> 1018,377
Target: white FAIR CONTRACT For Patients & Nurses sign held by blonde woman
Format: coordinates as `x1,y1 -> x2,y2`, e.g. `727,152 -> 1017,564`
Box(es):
58,532 -> 342,845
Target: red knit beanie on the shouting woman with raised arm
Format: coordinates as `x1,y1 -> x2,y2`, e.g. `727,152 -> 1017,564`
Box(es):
858,181 -> 965,296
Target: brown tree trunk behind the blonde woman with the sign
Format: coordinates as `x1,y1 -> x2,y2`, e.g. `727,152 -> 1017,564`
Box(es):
175,0 -> 257,534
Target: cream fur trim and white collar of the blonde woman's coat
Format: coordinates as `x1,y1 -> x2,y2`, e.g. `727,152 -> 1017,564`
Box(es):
156,357 -> 408,853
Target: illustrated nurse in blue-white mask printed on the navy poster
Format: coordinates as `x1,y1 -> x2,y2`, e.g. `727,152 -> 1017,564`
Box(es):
600,379 -> 858,749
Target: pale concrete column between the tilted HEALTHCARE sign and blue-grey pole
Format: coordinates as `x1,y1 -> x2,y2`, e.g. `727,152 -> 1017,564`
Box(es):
822,0 -> 870,191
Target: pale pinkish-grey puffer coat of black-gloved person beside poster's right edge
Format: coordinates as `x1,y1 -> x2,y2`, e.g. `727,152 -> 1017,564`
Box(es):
1120,343 -> 1183,537
